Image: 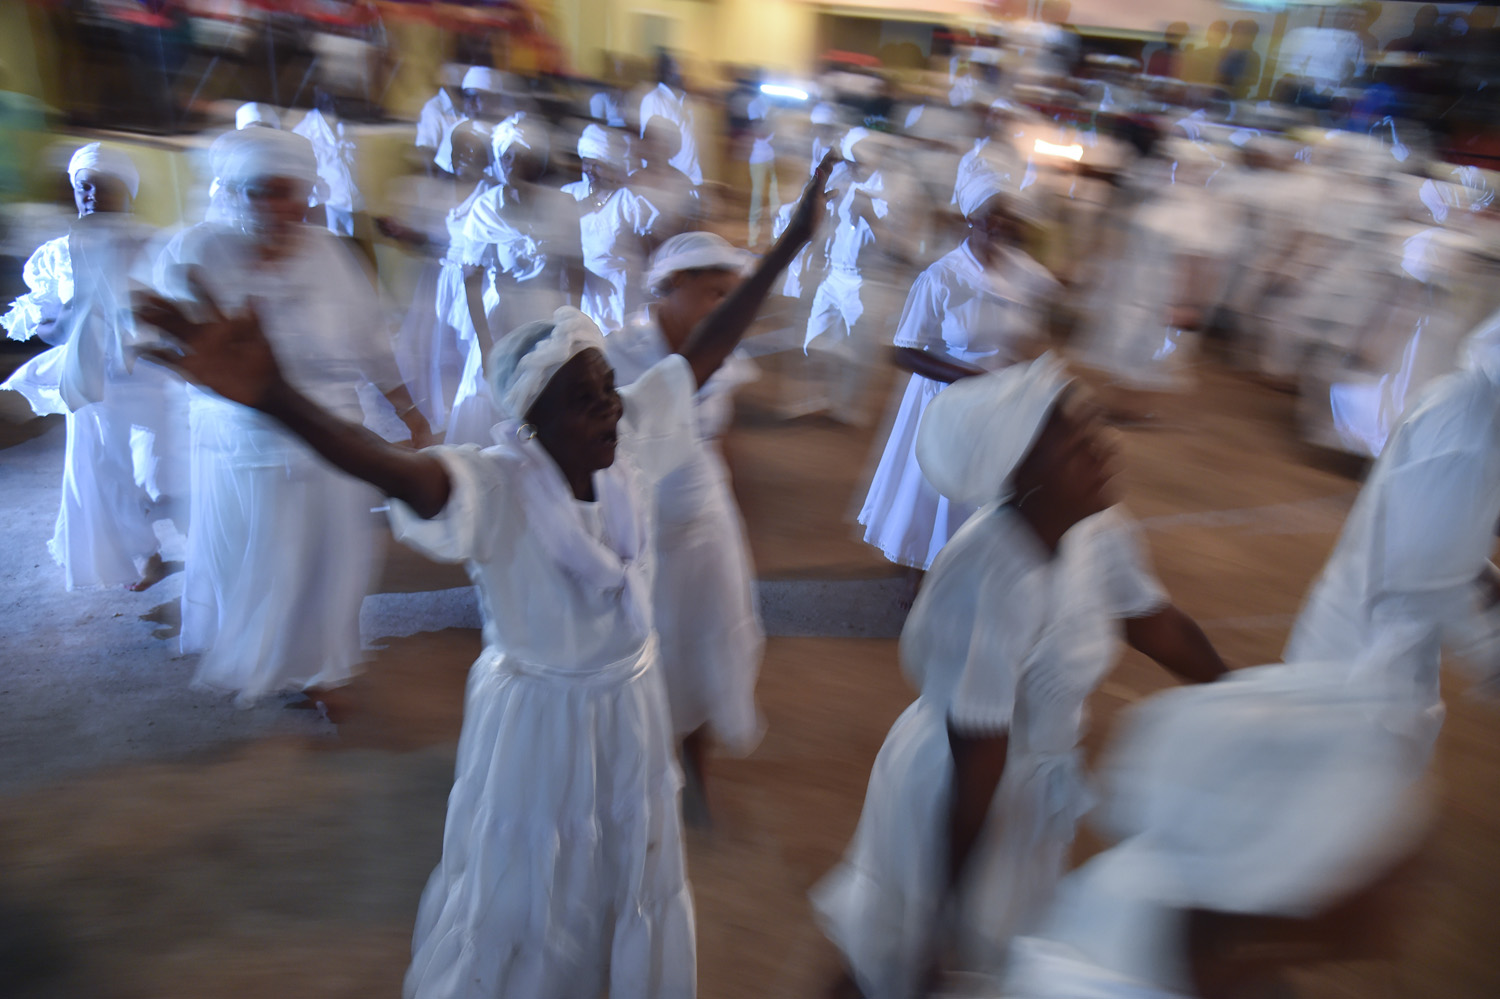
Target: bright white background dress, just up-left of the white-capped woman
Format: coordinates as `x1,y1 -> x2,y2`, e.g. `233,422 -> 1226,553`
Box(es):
563,180 -> 662,336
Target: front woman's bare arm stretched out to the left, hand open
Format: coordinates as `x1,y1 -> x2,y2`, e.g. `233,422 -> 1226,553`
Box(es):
135,275 -> 452,518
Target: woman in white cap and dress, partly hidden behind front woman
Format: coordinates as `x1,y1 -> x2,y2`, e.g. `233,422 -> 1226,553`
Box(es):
608,233 -> 765,825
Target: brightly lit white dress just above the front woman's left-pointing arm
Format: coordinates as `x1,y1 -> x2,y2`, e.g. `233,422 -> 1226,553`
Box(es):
395,182 -> 495,444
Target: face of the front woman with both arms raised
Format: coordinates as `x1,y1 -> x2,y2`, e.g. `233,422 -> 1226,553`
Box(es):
527,348 -> 626,501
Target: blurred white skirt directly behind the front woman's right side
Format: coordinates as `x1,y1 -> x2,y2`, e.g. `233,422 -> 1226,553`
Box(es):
653,446 -> 765,756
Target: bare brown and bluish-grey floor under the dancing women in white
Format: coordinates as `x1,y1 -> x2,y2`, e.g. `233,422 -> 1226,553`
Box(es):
0,359 -> 1500,999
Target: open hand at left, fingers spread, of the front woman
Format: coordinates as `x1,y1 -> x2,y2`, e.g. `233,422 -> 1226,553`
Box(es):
135,269 -> 287,410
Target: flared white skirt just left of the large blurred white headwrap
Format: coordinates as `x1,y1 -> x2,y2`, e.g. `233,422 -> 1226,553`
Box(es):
860,375 -> 977,569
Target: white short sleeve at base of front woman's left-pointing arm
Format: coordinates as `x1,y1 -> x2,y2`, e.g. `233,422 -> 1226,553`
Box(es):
390,444 -> 522,563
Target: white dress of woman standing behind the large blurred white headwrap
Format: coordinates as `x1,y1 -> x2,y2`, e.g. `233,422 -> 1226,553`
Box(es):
860,240 -> 1056,569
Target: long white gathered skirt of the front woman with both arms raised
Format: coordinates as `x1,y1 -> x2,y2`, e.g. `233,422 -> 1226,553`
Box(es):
404,642 -> 696,999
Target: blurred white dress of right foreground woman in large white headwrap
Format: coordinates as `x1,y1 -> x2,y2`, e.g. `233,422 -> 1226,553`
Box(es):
813,507 -> 1166,999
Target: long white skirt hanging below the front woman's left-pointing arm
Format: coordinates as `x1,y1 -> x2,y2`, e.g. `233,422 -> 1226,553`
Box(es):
182,401 -> 380,705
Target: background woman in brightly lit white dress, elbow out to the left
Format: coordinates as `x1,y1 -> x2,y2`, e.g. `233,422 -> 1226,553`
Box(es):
378,120 -> 495,444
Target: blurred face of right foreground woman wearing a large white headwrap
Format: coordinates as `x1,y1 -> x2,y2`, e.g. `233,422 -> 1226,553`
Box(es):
1014,389 -> 1118,545
